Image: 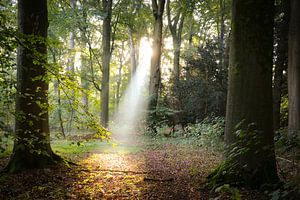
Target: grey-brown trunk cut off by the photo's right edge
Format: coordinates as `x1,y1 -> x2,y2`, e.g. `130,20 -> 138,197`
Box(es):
288,0 -> 300,137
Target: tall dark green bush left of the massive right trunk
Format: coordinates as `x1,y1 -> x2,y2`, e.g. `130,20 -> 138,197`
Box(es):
170,40 -> 227,123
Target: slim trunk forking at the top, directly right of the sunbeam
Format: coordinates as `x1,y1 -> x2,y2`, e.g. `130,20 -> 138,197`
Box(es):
149,0 -> 165,109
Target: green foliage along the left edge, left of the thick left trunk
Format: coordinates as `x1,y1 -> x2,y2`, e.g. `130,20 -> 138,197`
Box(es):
0,0 -> 17,153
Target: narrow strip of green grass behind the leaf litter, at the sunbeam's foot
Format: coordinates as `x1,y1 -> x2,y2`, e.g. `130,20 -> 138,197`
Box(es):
0,132 -> 216,158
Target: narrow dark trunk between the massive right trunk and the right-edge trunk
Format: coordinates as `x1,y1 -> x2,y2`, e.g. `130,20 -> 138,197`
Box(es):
273,0 -> 290,131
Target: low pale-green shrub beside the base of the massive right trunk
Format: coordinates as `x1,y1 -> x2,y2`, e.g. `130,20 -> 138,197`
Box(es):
186,117 -> 225,150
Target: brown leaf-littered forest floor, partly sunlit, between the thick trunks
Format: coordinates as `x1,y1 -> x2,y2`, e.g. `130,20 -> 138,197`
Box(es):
0,133 -> 276,200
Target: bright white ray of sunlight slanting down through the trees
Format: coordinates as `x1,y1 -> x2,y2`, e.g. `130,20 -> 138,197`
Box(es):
110,38 -> 152,141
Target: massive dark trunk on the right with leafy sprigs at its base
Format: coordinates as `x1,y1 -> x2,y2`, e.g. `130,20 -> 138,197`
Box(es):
216,0 -> 278,188
